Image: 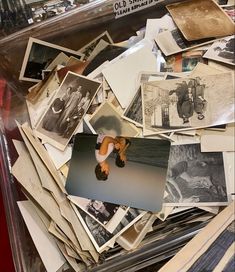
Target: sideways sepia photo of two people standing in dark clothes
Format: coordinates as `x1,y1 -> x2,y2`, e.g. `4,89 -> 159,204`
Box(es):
142,72 -> 235,135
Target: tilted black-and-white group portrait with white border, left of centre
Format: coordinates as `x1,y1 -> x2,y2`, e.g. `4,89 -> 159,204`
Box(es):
35,72 -> 101,150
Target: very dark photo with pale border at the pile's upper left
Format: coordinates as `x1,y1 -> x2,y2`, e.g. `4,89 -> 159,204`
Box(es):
19,37 -> 84,82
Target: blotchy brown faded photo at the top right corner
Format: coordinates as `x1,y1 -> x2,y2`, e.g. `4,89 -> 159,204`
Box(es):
167,0 -> 234,41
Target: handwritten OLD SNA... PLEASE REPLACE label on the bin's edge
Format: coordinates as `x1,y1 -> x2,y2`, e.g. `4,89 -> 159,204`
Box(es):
113,0 -> 164,18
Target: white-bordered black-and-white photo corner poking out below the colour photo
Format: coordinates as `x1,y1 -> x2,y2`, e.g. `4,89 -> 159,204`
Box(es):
75,207 -> 146,253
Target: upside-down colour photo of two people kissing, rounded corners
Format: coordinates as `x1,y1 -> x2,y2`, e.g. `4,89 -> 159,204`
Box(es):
66,134 -> 170,211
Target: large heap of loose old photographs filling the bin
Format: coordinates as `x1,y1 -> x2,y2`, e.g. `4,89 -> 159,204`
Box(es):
12,0 -> 235,272
